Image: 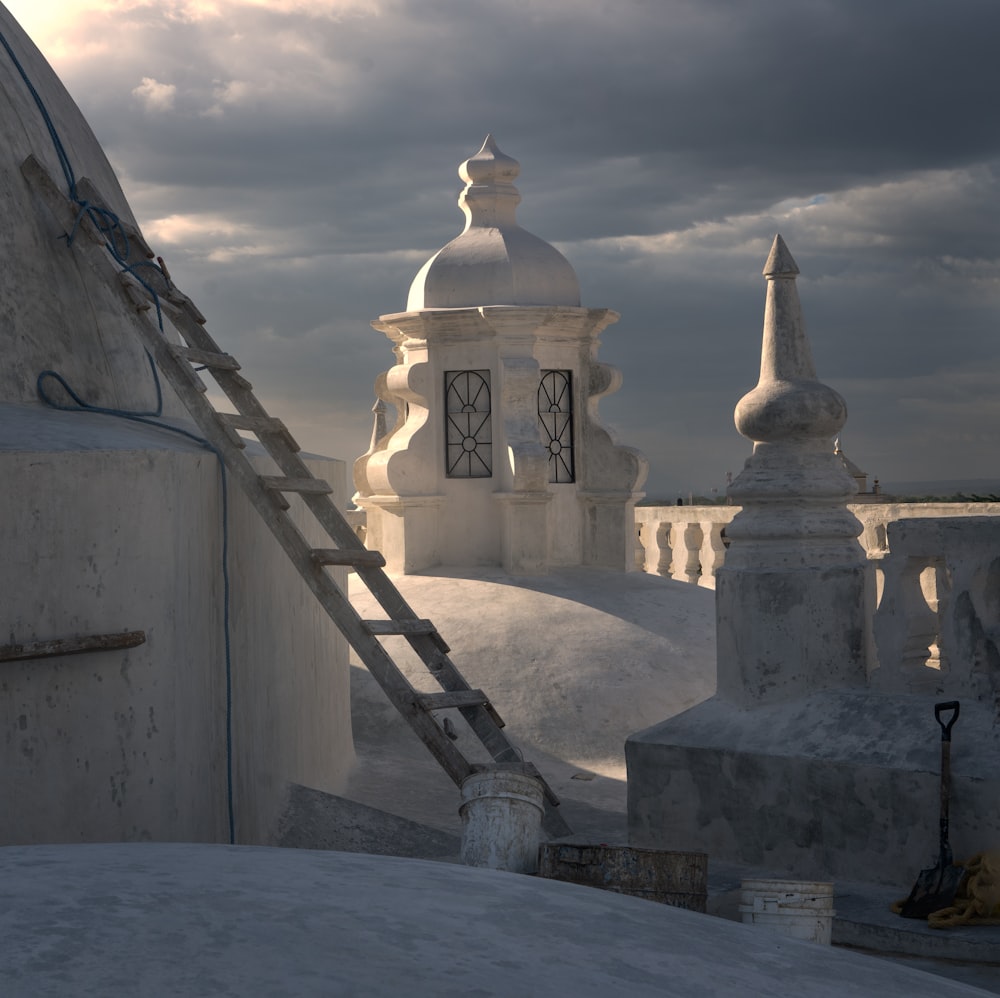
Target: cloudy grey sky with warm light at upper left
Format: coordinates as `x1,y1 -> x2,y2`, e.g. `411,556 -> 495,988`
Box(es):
6,0 -> 1000,498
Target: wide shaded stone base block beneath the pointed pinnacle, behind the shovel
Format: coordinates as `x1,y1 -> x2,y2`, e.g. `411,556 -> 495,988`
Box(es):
625,692 -> 1000,896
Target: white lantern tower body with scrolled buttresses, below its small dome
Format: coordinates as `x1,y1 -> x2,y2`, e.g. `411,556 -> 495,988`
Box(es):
354,306 -> 646,574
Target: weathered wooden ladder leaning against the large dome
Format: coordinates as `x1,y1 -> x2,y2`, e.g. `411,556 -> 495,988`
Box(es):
21,156 -> 570,838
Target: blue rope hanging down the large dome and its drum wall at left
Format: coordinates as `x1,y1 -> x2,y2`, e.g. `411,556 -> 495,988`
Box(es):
0,21 -> 236,845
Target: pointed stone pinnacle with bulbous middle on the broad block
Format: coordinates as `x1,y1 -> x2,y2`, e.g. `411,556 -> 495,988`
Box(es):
716,236 -> 870,706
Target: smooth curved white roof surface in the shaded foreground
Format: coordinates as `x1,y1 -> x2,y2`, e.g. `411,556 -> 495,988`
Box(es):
0,843 -> 985,998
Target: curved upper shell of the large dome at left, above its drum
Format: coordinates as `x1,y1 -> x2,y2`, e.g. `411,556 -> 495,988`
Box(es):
0,3 -> 183,418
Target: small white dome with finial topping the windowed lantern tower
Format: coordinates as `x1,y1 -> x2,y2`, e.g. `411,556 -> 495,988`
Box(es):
406,135 -> 580,312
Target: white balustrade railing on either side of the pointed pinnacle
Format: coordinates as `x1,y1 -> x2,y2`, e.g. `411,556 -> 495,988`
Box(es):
635,503 -> 1000,699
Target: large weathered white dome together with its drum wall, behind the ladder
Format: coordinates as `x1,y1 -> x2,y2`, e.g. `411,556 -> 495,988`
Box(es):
0,6 -> 353,843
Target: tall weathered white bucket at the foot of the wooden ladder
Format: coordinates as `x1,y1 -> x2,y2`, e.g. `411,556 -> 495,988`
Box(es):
458,768 -> 544,873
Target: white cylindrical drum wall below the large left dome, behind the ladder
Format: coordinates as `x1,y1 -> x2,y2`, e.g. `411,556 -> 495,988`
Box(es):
0,404 -> 353,844
